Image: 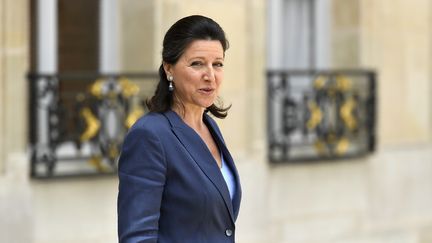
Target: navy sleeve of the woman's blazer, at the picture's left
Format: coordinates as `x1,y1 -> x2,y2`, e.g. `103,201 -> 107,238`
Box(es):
117,127 -> 166,243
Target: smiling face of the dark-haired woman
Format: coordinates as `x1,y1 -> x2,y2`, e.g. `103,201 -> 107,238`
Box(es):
164,40 -> 224,110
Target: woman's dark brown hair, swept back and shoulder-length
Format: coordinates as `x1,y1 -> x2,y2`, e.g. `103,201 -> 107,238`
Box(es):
146,15 -> 231,118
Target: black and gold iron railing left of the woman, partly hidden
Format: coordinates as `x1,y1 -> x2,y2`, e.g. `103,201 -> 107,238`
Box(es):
28,73 -> 158,178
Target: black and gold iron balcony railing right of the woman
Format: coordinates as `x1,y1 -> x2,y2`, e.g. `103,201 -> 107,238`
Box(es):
267,70 -> 376,163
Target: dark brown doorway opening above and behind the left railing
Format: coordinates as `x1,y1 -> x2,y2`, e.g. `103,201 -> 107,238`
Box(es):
57,0 -> 100,142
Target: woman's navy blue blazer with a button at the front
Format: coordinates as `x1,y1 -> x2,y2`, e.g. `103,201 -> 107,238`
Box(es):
117,111 -> 241,243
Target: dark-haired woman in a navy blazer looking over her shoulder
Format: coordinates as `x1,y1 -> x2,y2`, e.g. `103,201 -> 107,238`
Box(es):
118,15 -> 241,243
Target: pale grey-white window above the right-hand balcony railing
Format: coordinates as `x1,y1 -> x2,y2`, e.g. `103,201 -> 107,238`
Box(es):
267,0 -> 330,69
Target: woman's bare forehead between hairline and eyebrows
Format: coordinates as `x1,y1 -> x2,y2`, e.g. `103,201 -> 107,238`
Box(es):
183,40 -> 224,58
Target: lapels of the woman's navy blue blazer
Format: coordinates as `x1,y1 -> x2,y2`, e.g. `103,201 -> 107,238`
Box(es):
164,110 -> 240,223
